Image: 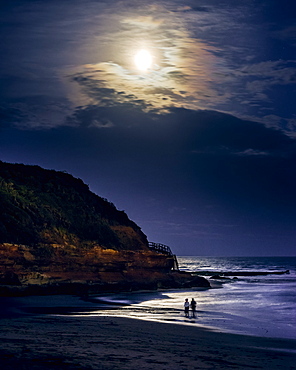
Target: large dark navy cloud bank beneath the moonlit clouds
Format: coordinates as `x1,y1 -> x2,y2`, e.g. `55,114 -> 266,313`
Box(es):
59,104 -> 296,217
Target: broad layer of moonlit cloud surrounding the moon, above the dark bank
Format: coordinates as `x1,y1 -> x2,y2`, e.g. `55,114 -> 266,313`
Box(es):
1,0 -> 295,130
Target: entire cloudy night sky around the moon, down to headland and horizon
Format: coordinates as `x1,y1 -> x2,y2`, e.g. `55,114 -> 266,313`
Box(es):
0,0 -> 296,256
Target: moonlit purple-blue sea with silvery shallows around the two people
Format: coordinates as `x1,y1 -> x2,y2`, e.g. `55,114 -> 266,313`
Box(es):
75,256 -> 296,339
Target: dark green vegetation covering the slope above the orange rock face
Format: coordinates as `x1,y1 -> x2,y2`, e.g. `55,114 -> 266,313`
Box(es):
0,162 -> 148,250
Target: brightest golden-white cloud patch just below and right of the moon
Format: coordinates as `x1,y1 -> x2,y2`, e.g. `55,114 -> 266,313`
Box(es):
69,39 -> 218,109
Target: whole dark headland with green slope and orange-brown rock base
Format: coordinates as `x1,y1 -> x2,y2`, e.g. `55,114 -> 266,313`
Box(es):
0,162 -> 209,295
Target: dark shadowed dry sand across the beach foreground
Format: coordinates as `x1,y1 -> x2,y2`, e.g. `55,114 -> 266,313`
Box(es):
0,315 -> 296,370
